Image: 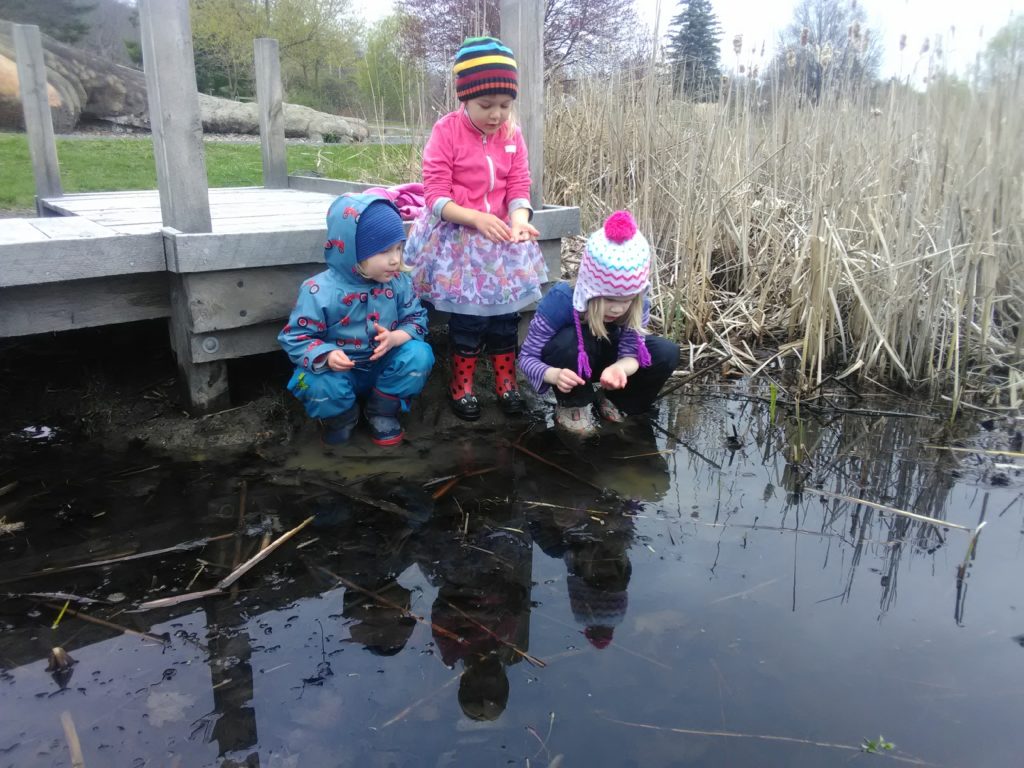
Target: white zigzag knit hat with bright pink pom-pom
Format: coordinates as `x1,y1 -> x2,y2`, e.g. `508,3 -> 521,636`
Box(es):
572,211 -> 650,312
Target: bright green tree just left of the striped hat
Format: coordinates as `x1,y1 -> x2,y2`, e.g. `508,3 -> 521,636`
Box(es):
357,14 -> 424,122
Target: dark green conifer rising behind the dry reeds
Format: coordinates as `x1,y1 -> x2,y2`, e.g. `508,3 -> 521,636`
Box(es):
669,0 -> 722,101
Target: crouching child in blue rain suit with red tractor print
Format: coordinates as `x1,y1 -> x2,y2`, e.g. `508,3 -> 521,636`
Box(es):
278,195 -> 434,445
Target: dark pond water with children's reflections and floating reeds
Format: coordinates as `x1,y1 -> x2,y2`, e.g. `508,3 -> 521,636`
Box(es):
0,325 -> 1024,768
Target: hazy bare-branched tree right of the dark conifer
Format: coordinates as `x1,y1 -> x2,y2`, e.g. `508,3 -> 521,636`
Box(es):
773,0 -> 882,101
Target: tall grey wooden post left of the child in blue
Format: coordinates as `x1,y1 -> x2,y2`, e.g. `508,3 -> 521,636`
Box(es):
138,0 -> 230,413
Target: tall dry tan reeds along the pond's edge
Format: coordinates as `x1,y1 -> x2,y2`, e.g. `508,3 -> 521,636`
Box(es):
545,64 -> 1024,412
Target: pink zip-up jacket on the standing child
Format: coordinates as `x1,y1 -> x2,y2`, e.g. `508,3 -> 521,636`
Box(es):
423,106 -> 534,220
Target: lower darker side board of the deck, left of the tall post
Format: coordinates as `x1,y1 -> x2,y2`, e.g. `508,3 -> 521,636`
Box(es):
0,272 -> 170,338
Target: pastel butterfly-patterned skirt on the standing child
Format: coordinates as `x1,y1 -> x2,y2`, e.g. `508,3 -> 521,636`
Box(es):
404,213 -> 548,315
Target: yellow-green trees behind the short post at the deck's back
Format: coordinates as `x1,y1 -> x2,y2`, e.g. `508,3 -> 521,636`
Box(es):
190,0 -> 360,111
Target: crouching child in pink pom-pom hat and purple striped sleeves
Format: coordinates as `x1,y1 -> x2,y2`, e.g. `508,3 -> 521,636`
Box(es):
519,211 -> 679,435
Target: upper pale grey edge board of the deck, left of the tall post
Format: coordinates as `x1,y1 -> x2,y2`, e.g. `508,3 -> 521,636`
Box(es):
0,231 -> 167,288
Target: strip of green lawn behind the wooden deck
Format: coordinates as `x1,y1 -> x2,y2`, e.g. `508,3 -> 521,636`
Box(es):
0,133 -> 419,209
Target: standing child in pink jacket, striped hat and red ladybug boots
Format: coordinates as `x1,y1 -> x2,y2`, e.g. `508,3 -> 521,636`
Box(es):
406,37 -> 548,421
